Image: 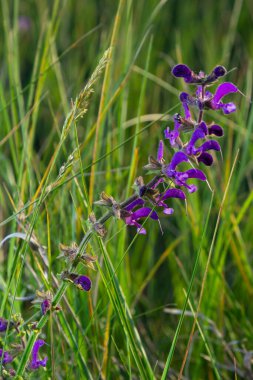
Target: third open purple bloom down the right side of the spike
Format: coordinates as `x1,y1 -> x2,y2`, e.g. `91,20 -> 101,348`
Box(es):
163,152 -> 206,193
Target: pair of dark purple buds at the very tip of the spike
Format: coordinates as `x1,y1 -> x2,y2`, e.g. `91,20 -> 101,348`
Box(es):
171,64 -> 227,85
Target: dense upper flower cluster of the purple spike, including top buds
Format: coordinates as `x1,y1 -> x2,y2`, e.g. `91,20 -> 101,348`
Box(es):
95,64 -> 238,234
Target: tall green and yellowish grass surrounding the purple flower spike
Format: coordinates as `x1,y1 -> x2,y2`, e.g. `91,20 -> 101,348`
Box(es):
0,0 -> 253,379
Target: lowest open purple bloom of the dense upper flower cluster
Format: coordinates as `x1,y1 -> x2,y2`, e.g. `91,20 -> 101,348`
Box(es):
121,198 -> 158,235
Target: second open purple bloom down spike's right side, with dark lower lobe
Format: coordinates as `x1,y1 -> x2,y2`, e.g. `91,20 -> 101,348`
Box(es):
184,121 -> 221,166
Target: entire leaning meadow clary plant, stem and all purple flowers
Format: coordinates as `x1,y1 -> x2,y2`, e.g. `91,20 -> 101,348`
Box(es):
0,64 -> 238,377
